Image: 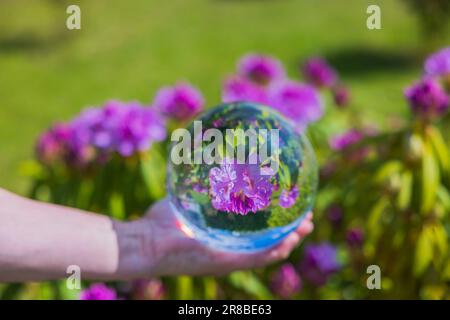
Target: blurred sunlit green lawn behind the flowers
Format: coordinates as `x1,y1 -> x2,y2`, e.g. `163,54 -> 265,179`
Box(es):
0,0 -> 448,193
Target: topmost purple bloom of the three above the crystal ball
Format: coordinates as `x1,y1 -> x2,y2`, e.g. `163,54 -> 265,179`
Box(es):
238,54 -> 285,85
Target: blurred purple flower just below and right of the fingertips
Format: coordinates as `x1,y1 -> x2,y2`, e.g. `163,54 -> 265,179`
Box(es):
300,242 -> 341,286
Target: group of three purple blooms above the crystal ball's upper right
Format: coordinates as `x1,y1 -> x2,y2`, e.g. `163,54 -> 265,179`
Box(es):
222,54 -> 323,131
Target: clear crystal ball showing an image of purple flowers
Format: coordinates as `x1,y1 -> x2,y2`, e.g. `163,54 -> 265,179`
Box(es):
167,102 -> 318,252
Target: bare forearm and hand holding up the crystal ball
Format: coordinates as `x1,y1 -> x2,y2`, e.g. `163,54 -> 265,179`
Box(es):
0,189 -> 313,282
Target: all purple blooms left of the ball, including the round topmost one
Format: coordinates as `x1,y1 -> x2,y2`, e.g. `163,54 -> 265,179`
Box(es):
36,83 -> 204,168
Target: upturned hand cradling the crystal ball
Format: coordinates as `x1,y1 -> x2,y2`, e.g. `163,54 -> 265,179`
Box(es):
115,199 -> 313,277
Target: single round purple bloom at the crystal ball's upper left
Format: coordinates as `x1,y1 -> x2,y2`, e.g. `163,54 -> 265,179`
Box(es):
153,83 -> 205,121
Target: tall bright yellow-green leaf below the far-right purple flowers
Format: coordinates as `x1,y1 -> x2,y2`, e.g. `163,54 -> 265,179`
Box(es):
421,143 -> 440,214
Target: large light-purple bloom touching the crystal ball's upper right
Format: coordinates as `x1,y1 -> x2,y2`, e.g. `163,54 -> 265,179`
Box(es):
269,81 -> 323,131
